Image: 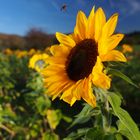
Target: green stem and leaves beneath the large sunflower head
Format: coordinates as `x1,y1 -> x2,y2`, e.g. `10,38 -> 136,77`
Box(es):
65,85 -> 140,140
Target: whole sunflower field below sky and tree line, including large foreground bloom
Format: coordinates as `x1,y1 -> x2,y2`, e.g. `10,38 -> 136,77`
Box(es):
0,4 -> 140,140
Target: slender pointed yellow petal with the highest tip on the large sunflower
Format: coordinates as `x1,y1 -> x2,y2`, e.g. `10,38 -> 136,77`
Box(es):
86,6 -> 95,39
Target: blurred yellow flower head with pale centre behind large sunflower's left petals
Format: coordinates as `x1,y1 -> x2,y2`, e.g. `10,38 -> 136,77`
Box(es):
29,54 -> 48,72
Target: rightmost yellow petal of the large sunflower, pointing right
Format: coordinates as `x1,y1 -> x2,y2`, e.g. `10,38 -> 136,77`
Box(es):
100,50 -> 127,62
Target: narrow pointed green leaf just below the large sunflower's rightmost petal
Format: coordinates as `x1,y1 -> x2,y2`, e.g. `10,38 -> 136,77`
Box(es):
108,69 -> 138,88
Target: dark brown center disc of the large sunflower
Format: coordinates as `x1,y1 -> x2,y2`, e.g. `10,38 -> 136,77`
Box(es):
66,39 -> 98,81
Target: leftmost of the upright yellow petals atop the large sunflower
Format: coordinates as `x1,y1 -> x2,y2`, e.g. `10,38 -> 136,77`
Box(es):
74,11 -> 87,40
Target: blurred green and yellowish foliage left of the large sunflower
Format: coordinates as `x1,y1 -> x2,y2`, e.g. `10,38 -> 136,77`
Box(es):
0,53 -> 71,140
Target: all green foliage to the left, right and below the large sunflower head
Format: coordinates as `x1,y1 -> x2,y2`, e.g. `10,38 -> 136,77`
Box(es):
0,44 -> 140,140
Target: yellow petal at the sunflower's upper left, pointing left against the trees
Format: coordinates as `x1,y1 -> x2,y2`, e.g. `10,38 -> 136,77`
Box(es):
56,32 -> 75,47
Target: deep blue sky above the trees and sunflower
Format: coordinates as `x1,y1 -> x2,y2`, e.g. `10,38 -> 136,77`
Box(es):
0,0 -> 140,35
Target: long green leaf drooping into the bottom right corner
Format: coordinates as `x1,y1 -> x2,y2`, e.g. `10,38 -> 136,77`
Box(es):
108,93 -> 140,140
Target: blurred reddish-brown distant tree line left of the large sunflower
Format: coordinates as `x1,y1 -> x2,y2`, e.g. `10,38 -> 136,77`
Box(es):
0,28 -> 58,50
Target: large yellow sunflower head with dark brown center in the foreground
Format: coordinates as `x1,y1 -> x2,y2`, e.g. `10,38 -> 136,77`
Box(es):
42,7 -> 126,107
